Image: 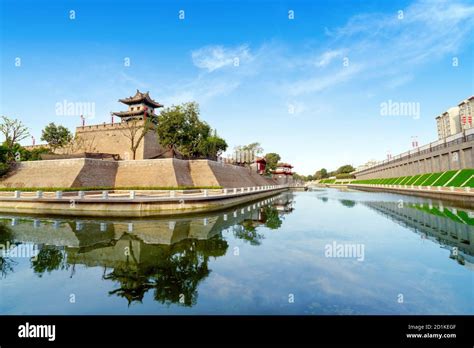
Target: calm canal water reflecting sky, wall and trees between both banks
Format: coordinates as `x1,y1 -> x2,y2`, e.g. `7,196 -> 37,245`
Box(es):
0,189 -> 474,315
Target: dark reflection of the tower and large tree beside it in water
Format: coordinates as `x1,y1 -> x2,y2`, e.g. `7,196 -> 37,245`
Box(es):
104,236 -> 228,306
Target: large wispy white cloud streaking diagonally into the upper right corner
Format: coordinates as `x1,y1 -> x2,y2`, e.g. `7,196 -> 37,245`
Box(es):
280,0 -> 474,95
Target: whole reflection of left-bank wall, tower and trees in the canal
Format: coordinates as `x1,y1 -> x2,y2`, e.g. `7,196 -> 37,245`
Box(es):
0,197 -> 292,306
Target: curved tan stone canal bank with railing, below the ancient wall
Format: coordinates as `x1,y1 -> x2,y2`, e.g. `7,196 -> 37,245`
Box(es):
0,185 -> 288,217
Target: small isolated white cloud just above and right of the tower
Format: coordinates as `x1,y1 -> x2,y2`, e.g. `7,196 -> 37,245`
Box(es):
191,45 -> 252,72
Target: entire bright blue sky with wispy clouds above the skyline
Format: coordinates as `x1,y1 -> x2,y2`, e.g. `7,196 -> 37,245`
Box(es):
0,0 -> 474,174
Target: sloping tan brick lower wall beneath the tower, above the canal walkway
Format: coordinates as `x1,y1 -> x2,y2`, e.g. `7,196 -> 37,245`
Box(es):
0,158 -> 275,188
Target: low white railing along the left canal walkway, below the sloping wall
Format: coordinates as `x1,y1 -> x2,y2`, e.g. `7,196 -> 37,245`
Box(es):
0,185 -> 289,202
